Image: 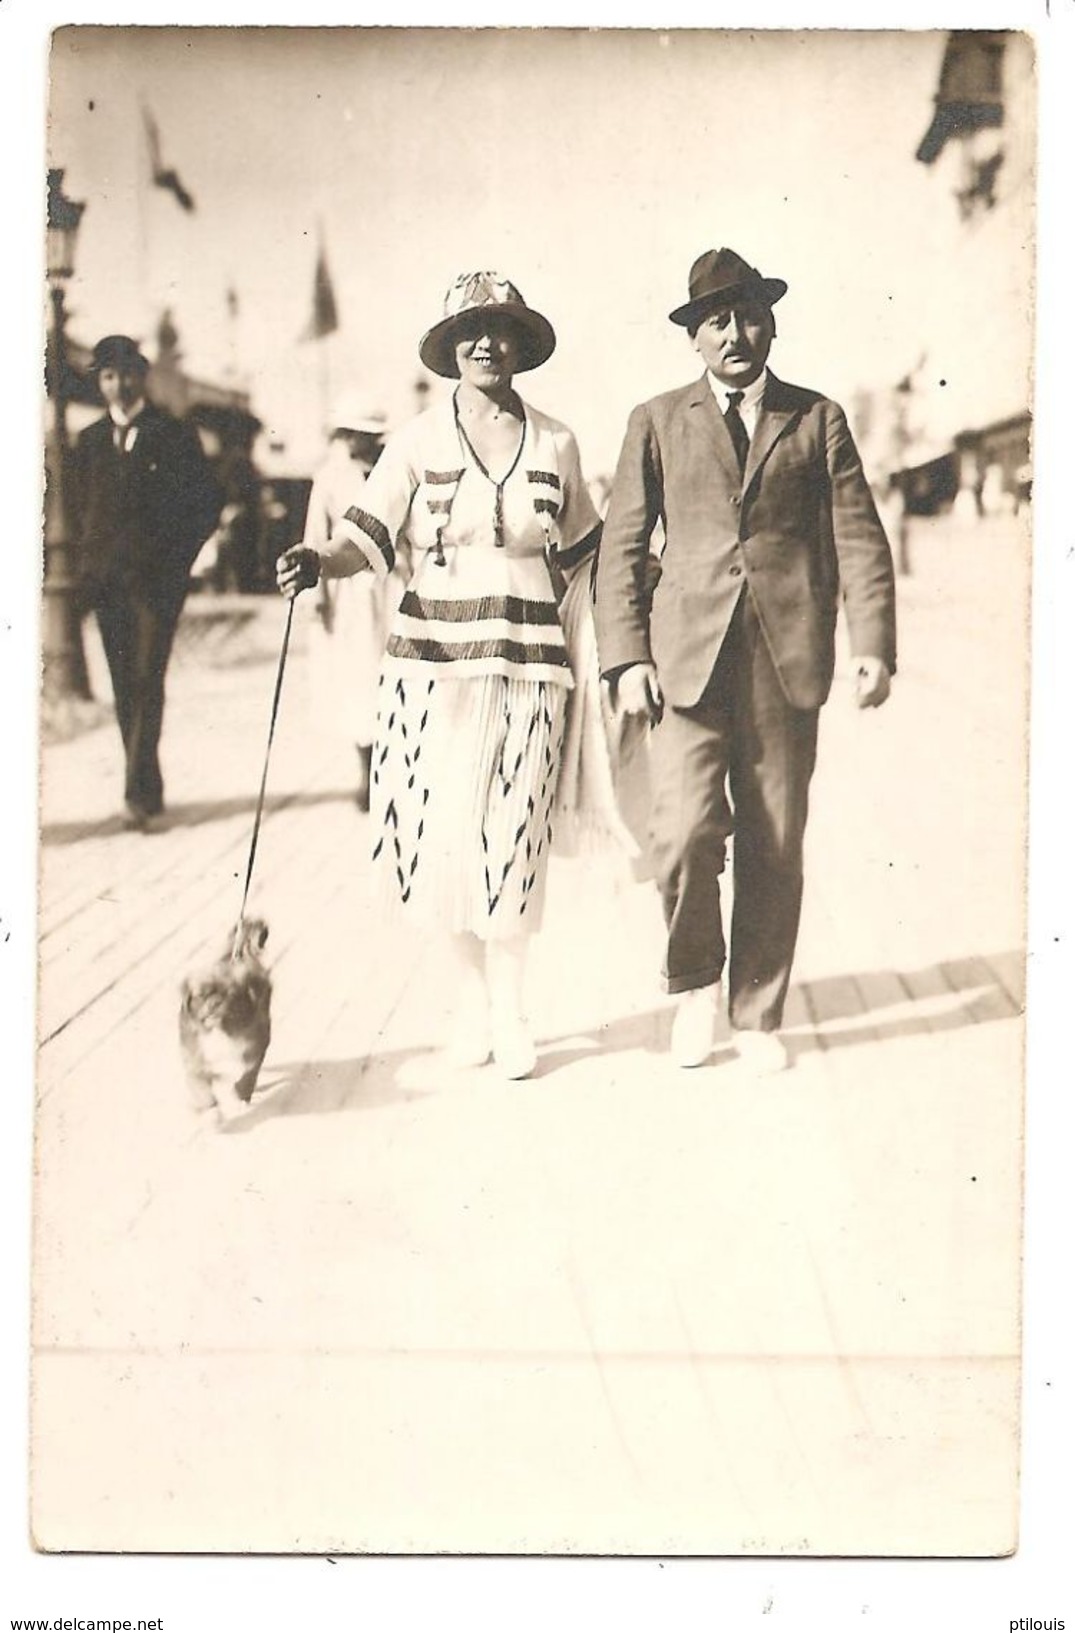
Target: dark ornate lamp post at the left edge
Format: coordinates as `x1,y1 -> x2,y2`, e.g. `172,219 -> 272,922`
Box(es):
41,170 -> 91,701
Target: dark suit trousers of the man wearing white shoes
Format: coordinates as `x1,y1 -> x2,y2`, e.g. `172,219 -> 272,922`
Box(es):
650,590 -> 819,1032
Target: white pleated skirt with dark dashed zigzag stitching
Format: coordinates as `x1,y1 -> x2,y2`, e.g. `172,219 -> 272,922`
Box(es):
369,670 -> 567,941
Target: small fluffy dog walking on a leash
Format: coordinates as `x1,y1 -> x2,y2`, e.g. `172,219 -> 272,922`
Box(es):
180,919 -> 273,1117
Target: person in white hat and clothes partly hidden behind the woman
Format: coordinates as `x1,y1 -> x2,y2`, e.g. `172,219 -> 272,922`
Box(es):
302,390 -> 392,812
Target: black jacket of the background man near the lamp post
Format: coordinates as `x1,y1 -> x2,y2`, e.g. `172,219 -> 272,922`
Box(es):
72,403 -> 221,611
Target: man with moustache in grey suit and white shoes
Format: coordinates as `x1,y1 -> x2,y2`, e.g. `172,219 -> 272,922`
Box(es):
596,248 -> 895,1073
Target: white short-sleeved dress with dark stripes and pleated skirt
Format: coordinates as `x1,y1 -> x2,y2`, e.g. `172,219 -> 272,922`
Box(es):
337,388 -> 598,939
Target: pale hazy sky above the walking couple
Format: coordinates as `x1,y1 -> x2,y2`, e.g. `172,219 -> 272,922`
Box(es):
49,26 -> 1029,472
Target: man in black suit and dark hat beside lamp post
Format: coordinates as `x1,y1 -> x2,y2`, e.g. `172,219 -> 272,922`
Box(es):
72,335 -> 221,831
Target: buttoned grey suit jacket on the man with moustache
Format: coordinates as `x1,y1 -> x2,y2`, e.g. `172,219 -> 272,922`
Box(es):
596,374 -> 895,709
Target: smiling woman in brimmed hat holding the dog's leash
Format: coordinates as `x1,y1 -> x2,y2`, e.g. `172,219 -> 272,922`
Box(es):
278,273 -> 600,1078
